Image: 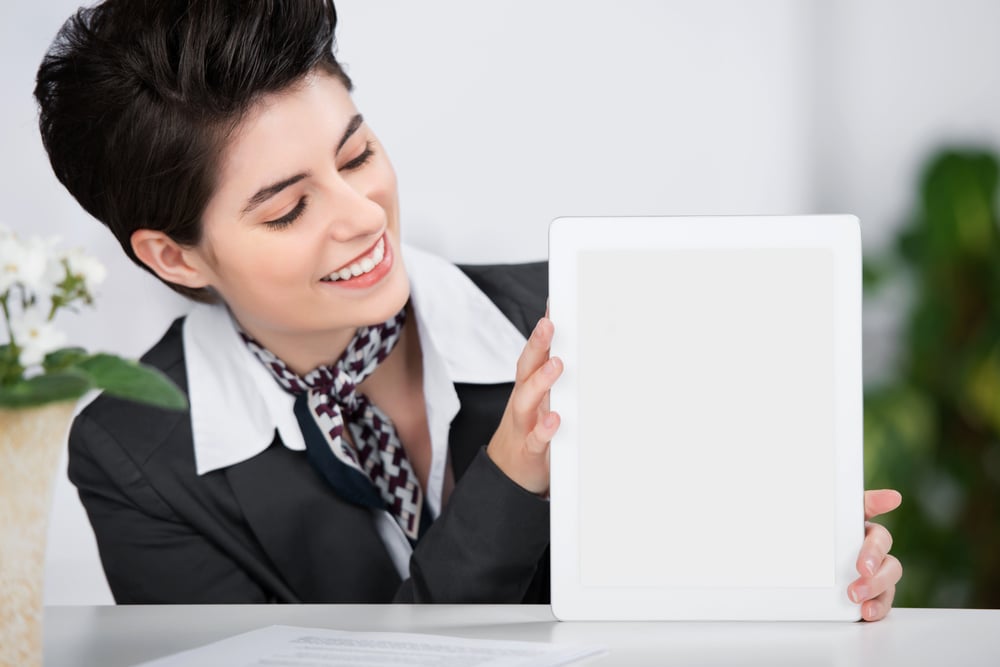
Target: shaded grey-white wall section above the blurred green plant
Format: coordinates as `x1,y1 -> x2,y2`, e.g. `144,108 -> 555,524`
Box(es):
812,0 -> 1000,382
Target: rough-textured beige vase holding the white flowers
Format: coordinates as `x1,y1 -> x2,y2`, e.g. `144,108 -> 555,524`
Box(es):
0,401 -> 76,667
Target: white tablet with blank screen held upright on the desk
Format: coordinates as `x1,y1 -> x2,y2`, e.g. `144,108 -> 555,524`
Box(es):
549,215 -> 864,620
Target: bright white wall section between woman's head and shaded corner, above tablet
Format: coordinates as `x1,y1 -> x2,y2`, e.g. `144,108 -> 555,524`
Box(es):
338,0 -> 810,261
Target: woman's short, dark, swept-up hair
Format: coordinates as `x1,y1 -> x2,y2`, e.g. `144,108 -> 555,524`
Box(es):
35,0 -> 351,301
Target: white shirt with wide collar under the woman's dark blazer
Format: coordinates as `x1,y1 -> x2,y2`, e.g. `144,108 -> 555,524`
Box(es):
183,246 -> 526,579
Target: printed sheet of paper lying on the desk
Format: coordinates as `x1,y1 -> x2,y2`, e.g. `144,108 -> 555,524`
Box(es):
136,625 -> 605,667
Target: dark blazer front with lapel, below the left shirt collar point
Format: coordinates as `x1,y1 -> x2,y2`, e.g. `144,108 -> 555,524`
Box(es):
226,436 -> 400,603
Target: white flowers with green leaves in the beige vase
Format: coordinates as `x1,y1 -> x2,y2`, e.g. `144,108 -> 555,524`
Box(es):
0,226 -> 187,409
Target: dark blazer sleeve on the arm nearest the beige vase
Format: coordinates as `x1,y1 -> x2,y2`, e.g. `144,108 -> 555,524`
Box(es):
69,414 -> 270,604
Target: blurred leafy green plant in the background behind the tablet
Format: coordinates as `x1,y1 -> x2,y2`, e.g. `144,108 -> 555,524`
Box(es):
865,150 -> 1000,608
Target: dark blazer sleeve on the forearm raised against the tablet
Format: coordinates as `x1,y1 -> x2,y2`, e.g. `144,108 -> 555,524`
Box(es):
396,448 -> 549,603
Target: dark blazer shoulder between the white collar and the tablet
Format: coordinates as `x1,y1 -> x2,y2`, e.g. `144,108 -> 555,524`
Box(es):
458,262 -> 549,338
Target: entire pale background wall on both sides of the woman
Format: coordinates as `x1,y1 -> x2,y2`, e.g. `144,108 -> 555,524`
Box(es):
0,0 -> 1000,603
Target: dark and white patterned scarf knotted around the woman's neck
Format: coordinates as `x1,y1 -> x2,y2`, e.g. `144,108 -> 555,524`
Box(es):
246,308 -> 430,543
